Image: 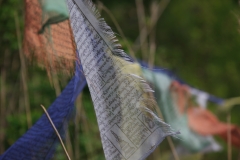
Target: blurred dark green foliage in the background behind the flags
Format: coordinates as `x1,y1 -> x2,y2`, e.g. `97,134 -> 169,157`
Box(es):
0,0 -> 240,160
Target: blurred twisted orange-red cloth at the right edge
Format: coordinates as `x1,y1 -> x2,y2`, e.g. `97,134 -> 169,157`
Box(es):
172,81 -> 240,147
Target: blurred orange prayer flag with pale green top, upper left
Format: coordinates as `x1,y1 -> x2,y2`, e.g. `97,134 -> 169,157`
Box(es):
23,0 -> 77,75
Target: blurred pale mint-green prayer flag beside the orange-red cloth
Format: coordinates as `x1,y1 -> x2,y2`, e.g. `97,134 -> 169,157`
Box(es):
143,69 -> 219,153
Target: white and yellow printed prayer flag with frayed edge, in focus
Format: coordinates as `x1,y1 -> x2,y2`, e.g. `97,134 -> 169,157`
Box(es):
67,0 -> 176,160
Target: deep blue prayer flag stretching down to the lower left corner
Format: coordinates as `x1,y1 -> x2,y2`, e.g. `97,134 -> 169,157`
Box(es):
0,62 -> 86,160
